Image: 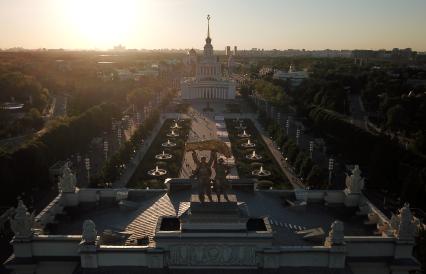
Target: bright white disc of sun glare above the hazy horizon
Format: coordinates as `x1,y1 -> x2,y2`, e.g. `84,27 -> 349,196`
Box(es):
66,0 -> 142,48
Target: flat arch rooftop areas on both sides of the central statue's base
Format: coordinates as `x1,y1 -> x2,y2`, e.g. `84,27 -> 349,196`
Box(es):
47,188 -> 375,246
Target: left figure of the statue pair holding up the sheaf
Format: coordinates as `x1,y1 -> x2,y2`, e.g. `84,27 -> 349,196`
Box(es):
192,150 -> 216,203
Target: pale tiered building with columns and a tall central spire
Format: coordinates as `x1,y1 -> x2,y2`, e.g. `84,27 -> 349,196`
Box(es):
181,17 -> 236,100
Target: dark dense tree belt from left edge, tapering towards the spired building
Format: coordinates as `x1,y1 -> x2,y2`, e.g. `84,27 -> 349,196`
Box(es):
0,104 -> 117,208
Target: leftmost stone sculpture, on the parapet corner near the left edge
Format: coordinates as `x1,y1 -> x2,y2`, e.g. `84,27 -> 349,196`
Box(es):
10,199 -> 34,238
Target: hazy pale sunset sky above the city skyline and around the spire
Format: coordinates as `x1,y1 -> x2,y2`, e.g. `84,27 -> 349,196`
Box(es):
0,0 -> 426,51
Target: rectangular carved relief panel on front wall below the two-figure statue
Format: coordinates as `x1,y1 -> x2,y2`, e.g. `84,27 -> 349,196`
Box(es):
168,245 -> 256,266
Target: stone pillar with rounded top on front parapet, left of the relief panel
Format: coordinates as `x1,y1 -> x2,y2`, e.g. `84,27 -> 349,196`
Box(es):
79,220 -> 98,268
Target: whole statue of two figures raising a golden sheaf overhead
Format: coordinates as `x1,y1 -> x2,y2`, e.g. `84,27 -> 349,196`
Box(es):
185,140 -> 231,203
